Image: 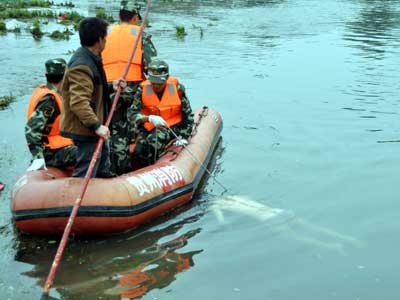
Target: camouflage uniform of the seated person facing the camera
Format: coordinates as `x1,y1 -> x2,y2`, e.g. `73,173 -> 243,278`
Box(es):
127,59 -> 194,166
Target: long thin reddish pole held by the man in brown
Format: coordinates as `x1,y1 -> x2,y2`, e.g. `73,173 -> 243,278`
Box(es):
41,0 -> 151,300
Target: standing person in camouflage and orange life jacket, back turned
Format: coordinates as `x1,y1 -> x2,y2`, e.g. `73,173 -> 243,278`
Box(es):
101,0 -> 157,175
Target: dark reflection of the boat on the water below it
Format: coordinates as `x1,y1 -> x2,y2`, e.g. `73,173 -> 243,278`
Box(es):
15,215 -> 203,300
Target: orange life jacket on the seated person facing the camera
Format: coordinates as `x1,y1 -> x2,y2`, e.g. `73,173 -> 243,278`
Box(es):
141,77 -> 182,131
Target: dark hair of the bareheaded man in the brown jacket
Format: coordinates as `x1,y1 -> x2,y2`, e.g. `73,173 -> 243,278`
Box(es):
79,17 -> 108,47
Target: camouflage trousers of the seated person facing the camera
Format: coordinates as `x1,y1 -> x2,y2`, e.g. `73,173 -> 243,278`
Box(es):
133,127 -> 175,167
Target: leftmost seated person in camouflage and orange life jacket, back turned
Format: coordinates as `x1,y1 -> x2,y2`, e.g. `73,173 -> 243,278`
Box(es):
25,58 -> 76,171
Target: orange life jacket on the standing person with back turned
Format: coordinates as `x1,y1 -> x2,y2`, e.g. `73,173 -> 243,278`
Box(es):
101,24 -> 143,82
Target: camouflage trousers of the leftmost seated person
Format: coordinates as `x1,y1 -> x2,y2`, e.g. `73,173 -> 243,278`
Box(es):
43,146 -> 77,169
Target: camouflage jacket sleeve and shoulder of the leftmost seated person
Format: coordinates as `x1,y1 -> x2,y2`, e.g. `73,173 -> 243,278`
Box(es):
25,84 -> 60,159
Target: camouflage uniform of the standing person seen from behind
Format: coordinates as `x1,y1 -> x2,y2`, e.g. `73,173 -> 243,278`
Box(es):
110,1 -> 157,175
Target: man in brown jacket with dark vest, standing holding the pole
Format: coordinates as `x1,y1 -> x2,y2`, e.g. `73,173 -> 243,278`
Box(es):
61,17 -> 115,177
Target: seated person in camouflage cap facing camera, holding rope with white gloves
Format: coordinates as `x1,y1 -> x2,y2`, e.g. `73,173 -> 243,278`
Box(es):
127,58 -> 194,167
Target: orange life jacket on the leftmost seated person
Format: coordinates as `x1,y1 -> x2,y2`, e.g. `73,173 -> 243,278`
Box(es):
27,84 -> 73,149
